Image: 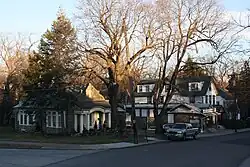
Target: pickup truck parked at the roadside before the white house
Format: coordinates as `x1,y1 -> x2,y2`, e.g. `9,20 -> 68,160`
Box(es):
165,123 -> 199,140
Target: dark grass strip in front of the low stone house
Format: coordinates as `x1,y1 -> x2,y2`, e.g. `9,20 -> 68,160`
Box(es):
0,127 -> 148,144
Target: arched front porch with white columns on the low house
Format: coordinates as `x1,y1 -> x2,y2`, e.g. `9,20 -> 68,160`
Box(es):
74,107 -> 111,133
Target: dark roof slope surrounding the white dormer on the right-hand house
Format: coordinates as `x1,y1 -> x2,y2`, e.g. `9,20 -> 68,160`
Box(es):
176,76 -> 212,96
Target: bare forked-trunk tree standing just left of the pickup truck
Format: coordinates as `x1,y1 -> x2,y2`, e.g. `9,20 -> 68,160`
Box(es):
150,0 -> 237,131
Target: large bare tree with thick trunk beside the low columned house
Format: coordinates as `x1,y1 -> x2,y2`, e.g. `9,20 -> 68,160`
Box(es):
76,0 -> 154,128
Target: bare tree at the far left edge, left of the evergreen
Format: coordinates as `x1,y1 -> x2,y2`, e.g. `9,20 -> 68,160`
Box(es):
0,34 -> 35,124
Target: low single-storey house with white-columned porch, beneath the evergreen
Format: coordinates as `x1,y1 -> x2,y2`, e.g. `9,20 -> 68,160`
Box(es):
14,84 -> 124,134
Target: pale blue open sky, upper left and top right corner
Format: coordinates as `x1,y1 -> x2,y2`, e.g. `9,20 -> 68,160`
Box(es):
0,0 -> 250,39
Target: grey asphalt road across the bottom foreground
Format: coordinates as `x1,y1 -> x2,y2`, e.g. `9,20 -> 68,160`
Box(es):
0,132 -> 250,167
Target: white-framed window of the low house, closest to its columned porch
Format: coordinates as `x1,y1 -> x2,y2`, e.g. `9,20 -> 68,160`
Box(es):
47,112 -> 62,128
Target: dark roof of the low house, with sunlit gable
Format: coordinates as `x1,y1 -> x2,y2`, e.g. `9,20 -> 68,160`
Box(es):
14,85 -> 110,110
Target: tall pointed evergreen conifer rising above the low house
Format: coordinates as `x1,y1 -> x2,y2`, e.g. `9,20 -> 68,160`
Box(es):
25,10 -> 78,88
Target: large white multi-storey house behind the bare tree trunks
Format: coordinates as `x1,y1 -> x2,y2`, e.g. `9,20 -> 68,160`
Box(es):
126,76 -> 230,128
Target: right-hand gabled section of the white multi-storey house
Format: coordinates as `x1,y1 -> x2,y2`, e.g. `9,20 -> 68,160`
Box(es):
176,76 -> 231,124
